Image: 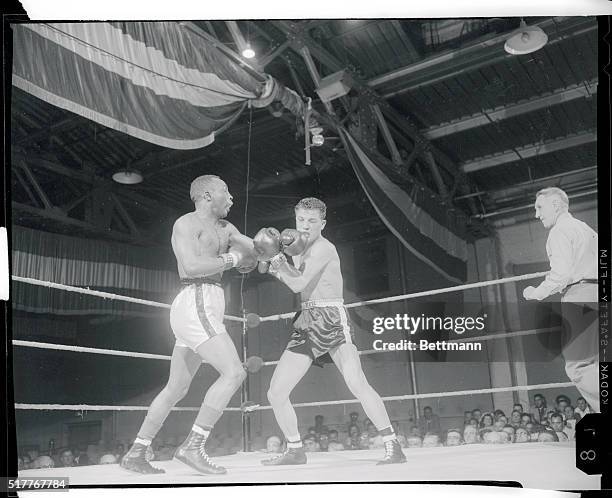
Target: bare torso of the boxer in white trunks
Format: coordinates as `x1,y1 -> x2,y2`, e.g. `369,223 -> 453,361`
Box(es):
171,212 -> 232,281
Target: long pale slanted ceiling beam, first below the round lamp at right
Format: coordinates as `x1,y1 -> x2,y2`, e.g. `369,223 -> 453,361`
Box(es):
422,78 -> 598,140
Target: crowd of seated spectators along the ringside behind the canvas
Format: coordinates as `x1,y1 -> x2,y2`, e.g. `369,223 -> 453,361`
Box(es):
18,394 -> 592,470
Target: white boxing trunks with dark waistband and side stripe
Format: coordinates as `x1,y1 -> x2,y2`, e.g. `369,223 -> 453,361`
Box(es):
170,279 -> 227,351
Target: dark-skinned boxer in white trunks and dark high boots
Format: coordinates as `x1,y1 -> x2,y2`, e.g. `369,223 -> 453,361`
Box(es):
121,175 -> 257,474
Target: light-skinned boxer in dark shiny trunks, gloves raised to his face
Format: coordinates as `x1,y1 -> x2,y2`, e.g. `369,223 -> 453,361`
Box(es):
254,197 -> 406,465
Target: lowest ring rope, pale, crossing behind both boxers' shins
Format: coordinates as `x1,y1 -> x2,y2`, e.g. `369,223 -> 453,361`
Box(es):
15,382 -> 574,411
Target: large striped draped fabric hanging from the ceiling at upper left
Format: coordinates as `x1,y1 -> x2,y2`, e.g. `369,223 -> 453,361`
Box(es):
12,22 -> 271,149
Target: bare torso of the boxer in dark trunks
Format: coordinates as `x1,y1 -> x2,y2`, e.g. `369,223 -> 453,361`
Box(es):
293,237 -> 343,302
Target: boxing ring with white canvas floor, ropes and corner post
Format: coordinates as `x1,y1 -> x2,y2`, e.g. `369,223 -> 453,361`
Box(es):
12,272 -> 601,490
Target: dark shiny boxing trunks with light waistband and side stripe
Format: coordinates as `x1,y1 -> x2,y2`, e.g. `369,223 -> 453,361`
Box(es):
286,299 -> 354,367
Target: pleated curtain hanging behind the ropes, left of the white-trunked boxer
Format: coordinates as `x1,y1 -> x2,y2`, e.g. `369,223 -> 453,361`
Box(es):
12,226 -> 179,316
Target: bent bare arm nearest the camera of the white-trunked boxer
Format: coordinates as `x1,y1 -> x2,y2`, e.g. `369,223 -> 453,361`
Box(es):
172,220 -> 231,278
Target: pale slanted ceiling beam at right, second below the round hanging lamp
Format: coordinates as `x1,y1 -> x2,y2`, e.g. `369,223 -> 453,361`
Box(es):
461,131 -> 597,173
